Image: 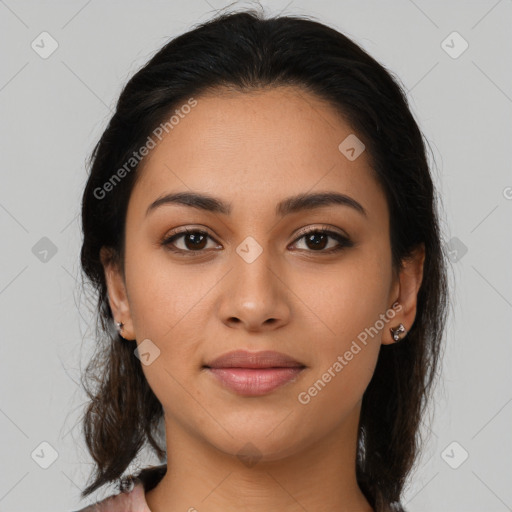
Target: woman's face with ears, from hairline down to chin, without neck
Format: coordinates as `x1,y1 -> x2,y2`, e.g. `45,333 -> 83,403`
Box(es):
101,87 -> 421,460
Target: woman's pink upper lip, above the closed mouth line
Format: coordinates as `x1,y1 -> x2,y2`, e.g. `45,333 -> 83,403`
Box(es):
205,350 -> 305,368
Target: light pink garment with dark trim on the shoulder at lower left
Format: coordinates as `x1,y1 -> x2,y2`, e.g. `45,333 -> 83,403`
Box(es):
76,464 -> 167,512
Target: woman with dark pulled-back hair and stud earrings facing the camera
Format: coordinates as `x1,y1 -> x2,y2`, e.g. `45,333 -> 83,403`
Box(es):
75,5 -> 447,512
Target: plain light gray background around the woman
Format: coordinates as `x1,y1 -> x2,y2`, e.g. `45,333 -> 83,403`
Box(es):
0,0 -> 512,512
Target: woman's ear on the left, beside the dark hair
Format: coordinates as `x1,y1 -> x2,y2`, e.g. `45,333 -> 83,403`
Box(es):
100,247 -> 135,340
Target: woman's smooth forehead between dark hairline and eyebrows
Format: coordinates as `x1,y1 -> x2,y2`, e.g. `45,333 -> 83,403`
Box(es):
130,86 -> 386,223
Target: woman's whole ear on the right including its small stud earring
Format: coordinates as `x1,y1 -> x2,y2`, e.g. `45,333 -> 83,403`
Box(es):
382,244 -> 425,345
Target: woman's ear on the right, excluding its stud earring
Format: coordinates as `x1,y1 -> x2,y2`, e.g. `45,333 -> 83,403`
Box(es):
382,243 -> 425,345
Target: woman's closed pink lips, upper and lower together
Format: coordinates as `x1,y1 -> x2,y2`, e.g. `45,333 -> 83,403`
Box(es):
204,350 -> 306,396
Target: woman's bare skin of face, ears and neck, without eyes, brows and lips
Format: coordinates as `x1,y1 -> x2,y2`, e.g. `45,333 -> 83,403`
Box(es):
102,87 -> 424,512
